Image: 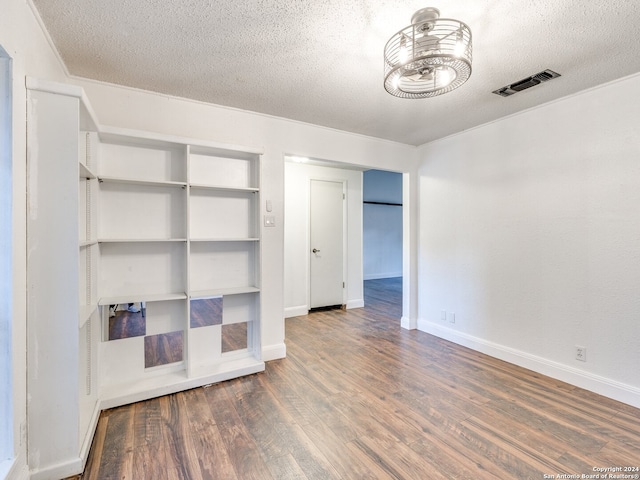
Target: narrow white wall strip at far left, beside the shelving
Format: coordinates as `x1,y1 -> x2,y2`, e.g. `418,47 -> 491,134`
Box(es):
0,0 -> 70,478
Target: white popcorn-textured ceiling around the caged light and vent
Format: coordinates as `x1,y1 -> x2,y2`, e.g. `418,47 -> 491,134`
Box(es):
30,0 -> 640,145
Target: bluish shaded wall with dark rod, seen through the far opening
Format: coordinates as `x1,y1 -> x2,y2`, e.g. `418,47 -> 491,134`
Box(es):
362,170 -> 402,280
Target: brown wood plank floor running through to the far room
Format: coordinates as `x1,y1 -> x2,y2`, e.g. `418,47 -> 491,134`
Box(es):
76,280 -> 640,480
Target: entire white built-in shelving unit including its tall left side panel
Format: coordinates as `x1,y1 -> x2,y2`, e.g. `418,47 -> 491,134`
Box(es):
27,79 -> 264,478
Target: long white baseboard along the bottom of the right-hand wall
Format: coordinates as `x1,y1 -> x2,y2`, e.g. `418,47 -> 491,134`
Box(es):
417,319 -> 640,408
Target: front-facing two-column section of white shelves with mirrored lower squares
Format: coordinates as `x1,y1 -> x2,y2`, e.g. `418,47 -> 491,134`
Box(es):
97,129 -> 264,403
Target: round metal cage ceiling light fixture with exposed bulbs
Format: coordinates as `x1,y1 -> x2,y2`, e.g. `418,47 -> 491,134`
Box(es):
384,8 -> 472,98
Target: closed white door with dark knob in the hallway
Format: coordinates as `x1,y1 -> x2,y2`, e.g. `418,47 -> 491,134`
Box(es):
309,180 -> 344,308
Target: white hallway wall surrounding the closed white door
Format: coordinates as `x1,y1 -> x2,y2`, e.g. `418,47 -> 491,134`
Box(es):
284,162 -> 364,317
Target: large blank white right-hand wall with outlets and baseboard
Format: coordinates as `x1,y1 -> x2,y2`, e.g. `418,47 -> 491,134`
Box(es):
418,72 -> 640,406
